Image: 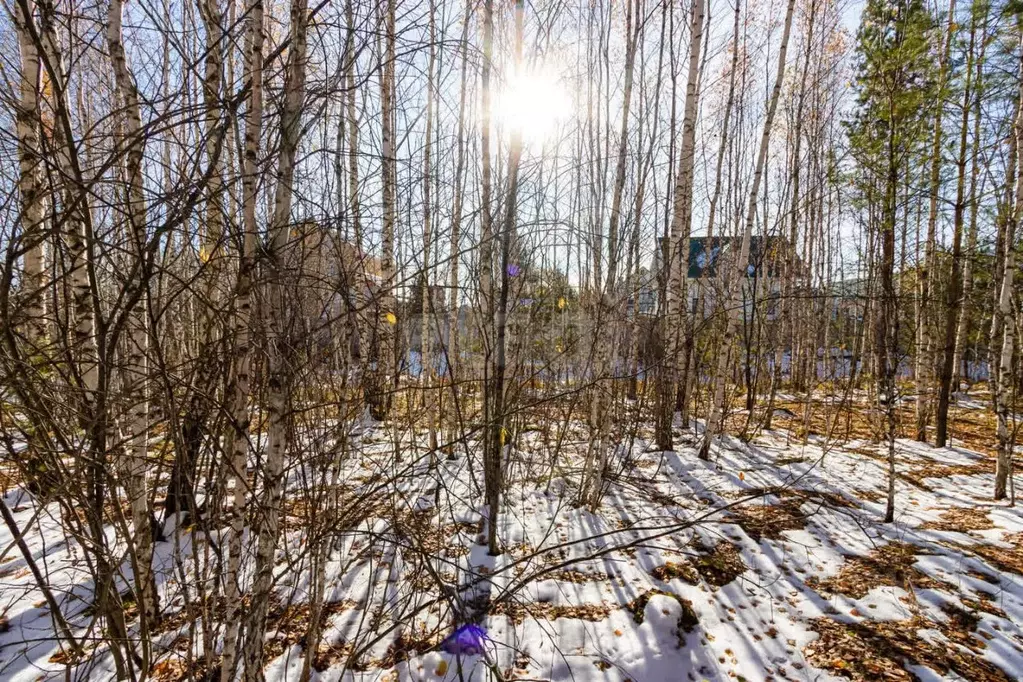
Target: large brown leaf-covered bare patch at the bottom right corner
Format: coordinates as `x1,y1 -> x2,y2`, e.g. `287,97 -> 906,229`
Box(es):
803,618 -> 1013,682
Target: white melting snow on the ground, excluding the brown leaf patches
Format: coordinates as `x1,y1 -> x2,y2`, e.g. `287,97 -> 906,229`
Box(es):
6,419 -> 1023,682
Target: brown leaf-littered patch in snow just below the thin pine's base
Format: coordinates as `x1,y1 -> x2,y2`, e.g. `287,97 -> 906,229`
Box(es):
806,542 -> 947,599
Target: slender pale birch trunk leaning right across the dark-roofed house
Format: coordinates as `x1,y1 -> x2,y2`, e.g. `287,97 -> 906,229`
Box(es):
700,0 -> 796,459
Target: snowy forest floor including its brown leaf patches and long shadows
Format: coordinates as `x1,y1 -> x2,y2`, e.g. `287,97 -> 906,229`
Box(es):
0,396 -> 1023,682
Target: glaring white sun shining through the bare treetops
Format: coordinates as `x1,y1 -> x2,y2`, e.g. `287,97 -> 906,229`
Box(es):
494,70 -> 572,144
